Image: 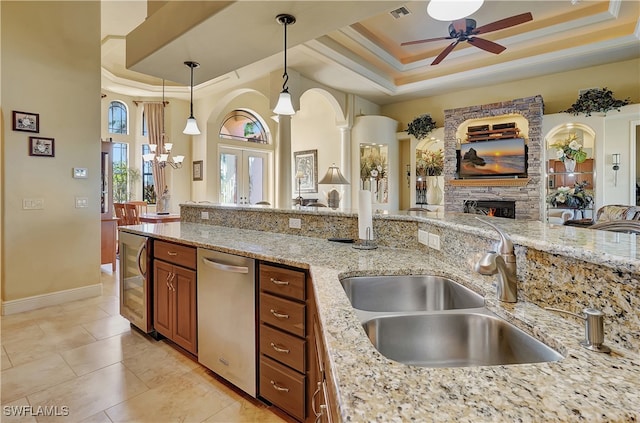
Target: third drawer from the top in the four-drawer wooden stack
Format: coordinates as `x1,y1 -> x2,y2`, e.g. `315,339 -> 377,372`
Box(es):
260,325 -> 306,373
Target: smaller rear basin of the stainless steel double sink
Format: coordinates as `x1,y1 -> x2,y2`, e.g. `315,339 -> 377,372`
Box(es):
341,275 -> 484,312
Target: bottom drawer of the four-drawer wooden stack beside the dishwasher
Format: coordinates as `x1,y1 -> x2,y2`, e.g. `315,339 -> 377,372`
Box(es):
260,356 -> 305,421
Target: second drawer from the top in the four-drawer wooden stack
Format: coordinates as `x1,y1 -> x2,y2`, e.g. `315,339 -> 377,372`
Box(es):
260,292 -> 305,337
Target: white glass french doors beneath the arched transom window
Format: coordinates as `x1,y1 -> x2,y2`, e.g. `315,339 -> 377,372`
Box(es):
219,147 -> 271,204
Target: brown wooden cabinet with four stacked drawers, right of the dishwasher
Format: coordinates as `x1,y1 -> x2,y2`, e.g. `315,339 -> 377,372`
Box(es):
258,263 -> 318,421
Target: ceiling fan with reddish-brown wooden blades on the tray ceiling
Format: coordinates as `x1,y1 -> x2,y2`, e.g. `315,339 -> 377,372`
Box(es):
400,12 -> 533,66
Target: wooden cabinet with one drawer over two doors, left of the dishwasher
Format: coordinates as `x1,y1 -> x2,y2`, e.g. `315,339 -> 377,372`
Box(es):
153,240 -> 198,354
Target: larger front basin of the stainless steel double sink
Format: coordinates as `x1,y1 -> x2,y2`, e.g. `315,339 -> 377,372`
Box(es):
363,310 -> 562,367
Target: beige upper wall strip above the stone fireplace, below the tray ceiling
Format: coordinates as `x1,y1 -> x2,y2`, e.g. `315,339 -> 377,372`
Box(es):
382,59 -> 640,131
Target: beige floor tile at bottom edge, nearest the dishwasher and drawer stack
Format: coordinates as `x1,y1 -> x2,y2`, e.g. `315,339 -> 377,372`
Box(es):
106,368 -> 238,422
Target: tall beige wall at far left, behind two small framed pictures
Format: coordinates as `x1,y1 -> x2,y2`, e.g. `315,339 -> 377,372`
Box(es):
0,1 -> 100,302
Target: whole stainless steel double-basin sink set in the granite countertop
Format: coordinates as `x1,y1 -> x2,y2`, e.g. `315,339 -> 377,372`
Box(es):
341,275 -> 562,367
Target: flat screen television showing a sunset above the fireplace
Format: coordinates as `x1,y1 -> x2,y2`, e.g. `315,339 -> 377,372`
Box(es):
458,138 -> 527,179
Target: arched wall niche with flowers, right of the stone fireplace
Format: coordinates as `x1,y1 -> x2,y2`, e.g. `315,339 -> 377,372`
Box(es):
542,122 -> 596,224
